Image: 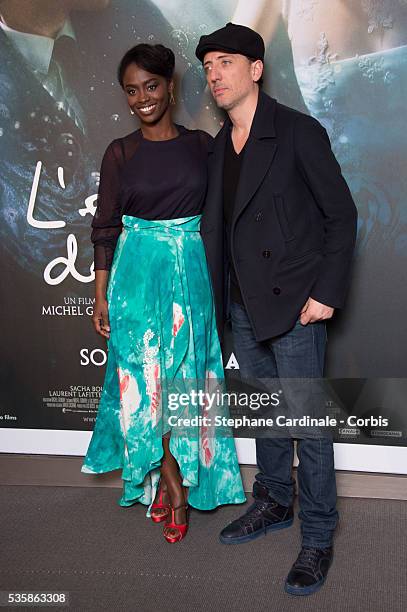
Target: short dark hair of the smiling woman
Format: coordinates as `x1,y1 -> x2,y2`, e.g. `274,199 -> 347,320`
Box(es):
117,43 -> 175,87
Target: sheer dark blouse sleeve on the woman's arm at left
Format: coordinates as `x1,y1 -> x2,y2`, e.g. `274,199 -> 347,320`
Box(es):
91,140 -> 122,270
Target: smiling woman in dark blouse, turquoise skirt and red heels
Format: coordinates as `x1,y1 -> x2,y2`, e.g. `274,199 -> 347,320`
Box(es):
82,44 -> 245,542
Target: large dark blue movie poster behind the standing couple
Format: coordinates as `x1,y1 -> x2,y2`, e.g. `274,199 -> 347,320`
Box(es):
0,0 -> 407,454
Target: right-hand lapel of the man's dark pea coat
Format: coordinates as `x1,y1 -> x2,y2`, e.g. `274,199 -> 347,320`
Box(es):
233,92 -> 277,224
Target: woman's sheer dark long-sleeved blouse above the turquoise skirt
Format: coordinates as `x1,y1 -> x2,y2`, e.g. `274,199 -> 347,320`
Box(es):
91,125 -> 212,270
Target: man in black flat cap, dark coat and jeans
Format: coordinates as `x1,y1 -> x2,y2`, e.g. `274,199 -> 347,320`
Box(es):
196,23 -> 356,595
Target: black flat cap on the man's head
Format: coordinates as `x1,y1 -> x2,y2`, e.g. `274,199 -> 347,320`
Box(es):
195,22 -> 264,62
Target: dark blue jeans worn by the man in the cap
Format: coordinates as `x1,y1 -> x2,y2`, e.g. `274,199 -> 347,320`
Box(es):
231,302 -> 338,548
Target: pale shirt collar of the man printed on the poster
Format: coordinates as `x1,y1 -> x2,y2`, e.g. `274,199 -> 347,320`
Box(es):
0,18 -> 76,75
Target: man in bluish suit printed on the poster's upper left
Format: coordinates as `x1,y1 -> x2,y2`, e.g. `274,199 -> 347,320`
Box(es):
0,0 -> 108,274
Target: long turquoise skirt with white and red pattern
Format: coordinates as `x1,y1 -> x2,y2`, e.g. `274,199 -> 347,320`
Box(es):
81,215 -> 246,516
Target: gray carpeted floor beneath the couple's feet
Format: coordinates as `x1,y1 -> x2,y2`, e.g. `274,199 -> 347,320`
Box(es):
0,486 -> 407,612
